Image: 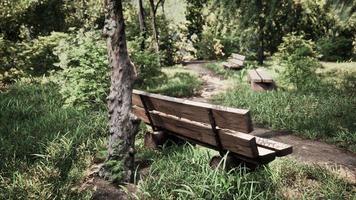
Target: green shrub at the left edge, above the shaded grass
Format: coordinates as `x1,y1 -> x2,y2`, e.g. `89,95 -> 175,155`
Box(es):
0,32 -> 68,84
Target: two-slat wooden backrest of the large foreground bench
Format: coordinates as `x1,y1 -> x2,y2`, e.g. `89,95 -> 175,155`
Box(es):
132,90 -> 258,158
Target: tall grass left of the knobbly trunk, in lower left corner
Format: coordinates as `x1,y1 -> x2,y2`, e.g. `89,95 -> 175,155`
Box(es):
0,82 -> 107,199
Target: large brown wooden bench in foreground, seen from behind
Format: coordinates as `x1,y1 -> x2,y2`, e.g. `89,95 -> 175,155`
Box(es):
132,90 -> 293,167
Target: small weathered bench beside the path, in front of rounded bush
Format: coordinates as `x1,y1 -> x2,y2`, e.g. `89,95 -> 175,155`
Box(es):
247,68 -> 275,91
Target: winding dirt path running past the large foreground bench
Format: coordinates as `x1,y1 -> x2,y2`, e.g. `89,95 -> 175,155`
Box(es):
185,63 -> 356,183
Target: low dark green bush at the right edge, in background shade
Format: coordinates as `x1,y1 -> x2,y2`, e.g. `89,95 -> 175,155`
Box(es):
317,36 -> 353,61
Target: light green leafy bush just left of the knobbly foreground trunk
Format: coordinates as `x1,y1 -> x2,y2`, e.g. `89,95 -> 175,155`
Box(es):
55,30 -> 110,109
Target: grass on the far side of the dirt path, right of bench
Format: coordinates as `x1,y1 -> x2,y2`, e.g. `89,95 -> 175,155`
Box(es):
208,63 -> 356,152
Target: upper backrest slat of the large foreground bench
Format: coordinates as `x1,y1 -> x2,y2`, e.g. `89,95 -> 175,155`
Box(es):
133,90 -> 253,133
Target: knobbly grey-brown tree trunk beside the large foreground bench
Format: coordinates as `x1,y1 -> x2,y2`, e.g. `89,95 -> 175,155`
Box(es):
100,0 -> 139,183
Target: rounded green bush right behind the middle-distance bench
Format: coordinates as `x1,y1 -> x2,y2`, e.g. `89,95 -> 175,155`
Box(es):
275,34 -> 320,90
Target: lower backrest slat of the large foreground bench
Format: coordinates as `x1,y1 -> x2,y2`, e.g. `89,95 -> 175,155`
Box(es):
151,111 -> 258,158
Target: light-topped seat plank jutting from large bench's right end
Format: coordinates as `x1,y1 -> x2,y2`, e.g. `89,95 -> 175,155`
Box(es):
256,137 -> 293,157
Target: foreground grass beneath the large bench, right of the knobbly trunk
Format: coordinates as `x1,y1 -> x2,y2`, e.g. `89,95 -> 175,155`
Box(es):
138,145 -> 356,199
